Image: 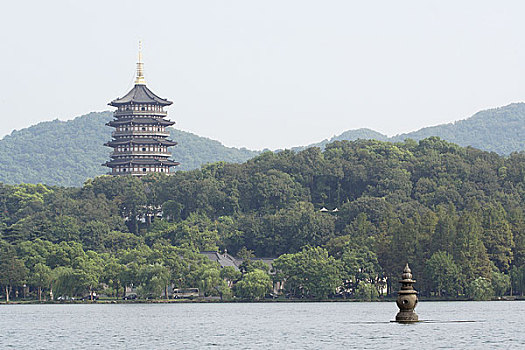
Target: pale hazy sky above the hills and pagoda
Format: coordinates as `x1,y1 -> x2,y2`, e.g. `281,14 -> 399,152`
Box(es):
0,0 -> 525,149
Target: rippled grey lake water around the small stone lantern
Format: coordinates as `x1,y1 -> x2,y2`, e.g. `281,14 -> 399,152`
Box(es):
0,301 -> 525,349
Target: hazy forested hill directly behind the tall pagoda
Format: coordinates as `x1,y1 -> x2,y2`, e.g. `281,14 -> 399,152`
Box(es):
0,112 -> 257,186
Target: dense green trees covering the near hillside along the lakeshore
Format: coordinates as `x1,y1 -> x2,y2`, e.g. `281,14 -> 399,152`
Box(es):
0,137 -> 525,299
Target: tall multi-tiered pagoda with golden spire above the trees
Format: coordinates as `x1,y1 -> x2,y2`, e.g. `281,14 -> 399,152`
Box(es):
102,45 -> 179,176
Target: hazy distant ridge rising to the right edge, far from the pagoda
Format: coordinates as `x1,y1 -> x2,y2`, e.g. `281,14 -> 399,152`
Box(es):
295,103 -> 525,155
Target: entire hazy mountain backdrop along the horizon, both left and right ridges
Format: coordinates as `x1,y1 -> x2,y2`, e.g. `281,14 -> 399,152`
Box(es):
0,103 -> 525,186
